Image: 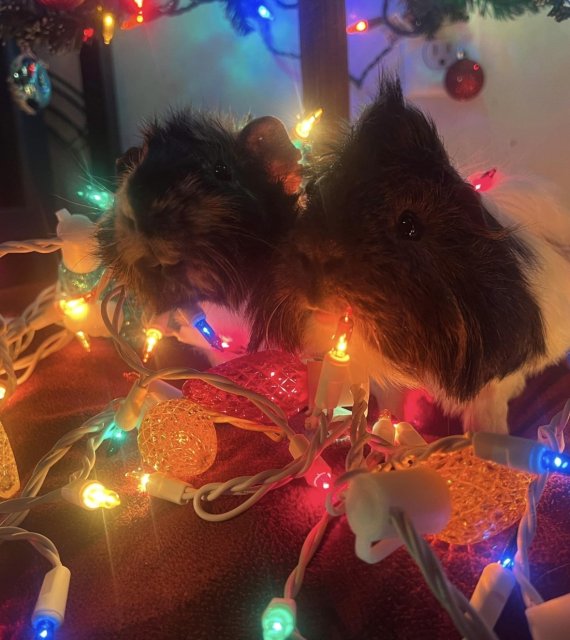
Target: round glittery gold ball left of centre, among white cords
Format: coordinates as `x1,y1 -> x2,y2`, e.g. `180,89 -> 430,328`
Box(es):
138,400 -> 218,480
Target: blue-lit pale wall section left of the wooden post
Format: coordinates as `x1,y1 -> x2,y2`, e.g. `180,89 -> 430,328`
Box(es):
108,3 -> 301,148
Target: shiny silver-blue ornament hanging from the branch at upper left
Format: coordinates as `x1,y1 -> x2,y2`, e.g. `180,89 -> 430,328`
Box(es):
8,53 -> 51,116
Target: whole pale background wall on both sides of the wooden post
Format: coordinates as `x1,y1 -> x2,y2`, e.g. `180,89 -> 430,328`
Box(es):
108,0 -> 570,204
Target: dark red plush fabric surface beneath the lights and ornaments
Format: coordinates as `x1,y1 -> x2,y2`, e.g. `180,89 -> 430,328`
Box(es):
0,286 -> 570,640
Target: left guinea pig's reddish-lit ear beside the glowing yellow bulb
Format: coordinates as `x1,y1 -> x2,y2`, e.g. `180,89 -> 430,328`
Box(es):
238,116 -> 301,194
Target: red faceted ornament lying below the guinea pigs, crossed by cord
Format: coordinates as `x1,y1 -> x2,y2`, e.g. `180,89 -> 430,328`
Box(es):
182,351 -> 307,424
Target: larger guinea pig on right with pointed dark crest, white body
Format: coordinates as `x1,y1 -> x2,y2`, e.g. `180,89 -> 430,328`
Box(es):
250,79 -> 570,432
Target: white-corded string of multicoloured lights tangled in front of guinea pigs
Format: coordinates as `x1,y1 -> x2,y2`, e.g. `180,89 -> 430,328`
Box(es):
0,223 -> 570,640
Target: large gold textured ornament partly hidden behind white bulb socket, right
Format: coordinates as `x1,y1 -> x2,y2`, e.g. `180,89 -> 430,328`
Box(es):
414,447 -> 533,544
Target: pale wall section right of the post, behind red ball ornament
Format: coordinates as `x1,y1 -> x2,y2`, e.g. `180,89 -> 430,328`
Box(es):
347,0 -> 570,205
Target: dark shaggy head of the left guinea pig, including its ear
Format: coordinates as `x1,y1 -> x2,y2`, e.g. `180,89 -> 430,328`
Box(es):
97,111 -> 301,313
